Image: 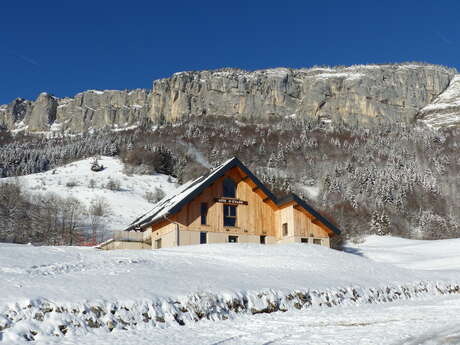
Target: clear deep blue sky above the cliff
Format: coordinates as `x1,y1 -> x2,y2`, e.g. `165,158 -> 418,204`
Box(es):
0,0 -> 460,104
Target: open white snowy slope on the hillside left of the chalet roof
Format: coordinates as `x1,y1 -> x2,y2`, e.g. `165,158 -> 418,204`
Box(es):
0,156 -> 178,237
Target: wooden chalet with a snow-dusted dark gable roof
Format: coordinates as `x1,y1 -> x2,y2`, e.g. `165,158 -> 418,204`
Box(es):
100,157 -> 340,249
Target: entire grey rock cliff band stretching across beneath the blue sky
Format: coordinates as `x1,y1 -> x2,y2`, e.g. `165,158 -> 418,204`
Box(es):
0,64 -> 460,132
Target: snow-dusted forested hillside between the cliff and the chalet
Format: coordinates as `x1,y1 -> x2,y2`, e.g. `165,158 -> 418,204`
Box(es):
0,116 -> 460,245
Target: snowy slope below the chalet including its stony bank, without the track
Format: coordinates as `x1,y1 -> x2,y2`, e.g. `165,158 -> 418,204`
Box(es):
0,241 -> 460,344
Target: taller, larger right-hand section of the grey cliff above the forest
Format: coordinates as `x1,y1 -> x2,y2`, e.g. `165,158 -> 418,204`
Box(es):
151,65 -> 454,121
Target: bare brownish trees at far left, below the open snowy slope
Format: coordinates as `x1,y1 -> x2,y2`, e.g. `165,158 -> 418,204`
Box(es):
0,180 -> 110,245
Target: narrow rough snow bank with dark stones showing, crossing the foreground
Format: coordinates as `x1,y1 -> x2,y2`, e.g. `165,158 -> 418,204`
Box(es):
0,282 -> 460,341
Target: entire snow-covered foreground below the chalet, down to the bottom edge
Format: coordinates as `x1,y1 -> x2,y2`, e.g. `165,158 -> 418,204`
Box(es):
0,237 -> 460,345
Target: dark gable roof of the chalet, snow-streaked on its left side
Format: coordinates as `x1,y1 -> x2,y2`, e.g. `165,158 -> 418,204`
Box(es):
125,157 -> 340,234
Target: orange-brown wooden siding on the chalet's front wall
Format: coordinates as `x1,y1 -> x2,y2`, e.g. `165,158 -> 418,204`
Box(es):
152,167 -> 332,246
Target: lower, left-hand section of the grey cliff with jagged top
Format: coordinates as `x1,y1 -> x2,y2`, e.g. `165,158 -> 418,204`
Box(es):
0,89 -> 150,132
